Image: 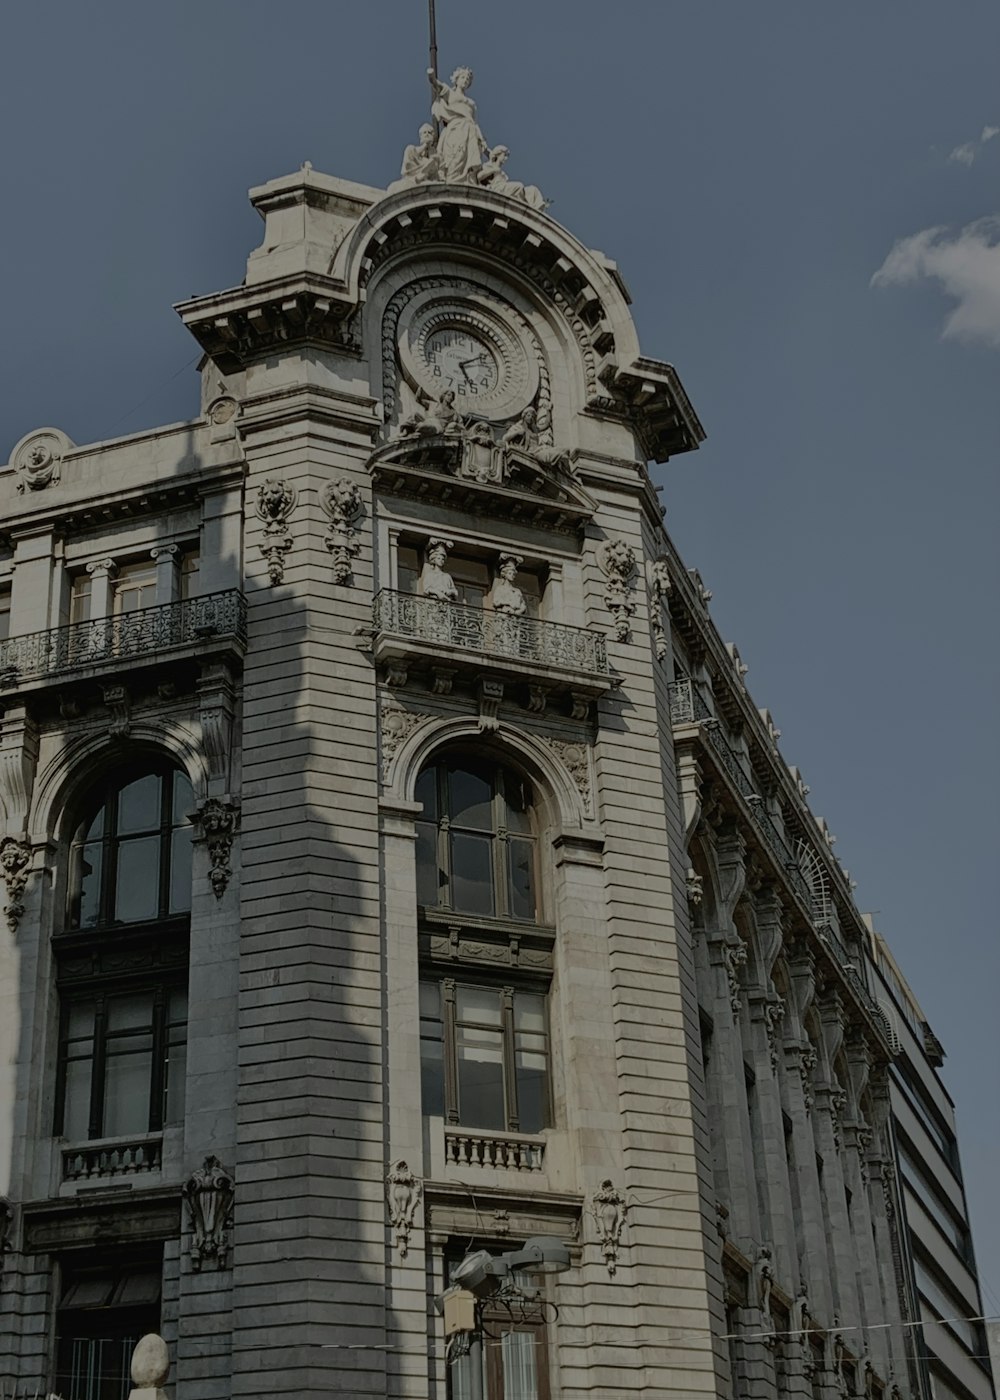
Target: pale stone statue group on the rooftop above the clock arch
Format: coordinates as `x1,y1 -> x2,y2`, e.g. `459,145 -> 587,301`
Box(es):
389,67 -> 548,210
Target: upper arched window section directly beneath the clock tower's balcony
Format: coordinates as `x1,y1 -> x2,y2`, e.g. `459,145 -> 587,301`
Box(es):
416,753 -> 538,920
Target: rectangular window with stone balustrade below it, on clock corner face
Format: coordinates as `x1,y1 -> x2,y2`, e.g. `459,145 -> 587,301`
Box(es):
420,977 -> 550,1133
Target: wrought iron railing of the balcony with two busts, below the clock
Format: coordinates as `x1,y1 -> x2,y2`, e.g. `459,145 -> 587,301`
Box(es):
374,588 -> 611,679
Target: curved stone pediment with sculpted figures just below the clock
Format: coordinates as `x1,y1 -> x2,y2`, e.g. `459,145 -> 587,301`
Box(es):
368,426 -> 597,532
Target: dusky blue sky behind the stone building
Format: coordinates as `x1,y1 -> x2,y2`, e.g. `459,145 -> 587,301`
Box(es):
0,0 -> 1000,1313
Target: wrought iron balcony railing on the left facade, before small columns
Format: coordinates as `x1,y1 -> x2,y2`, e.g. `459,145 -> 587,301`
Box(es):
0,588 -> 246,690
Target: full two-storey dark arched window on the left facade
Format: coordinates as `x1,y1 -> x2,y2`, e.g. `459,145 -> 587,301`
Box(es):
53,764 -> 193,1141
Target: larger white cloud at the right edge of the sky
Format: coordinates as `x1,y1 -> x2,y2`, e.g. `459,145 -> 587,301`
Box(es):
871,216 -> 1000,349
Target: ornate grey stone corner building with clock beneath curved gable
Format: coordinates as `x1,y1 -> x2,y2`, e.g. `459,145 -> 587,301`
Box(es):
0,70 -> 978,1400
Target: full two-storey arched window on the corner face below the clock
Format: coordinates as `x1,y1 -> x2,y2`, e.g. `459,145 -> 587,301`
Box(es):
416,752 -> 555,1136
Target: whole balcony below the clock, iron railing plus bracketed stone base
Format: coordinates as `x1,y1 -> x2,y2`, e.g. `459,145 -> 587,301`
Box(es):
374,588 -> 615,710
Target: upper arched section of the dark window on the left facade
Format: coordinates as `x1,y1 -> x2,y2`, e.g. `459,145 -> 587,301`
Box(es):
67,769 -> 195,928
